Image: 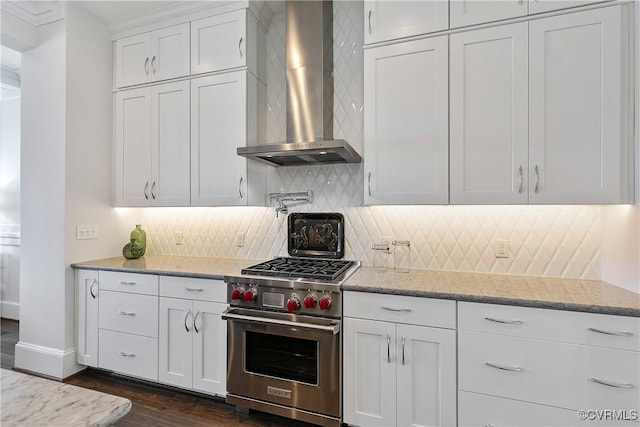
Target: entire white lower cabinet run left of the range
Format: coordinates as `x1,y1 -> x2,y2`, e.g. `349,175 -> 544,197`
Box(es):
76,269 -> 227,396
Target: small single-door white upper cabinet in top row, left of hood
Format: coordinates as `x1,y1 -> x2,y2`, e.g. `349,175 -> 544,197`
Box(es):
191,9 -> 265,75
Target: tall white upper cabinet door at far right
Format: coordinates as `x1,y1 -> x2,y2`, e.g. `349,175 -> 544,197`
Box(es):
529,6 -> 627,203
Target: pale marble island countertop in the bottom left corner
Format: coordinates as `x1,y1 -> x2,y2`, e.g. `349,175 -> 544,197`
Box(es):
0,369 -> 131,427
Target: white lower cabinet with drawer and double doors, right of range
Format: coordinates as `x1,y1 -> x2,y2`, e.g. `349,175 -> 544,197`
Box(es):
343,292 -> 456,426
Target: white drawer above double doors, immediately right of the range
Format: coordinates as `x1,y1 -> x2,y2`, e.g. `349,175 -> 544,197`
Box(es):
344,292 -> 456,329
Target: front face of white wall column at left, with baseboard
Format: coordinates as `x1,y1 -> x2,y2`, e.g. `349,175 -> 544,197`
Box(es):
15,16 -> 67,378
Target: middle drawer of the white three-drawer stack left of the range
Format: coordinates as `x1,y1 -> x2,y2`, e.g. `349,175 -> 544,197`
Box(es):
98,290 -> 158,338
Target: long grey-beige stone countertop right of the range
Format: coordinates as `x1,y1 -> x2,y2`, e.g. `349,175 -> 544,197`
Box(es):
342,267 -> 640,317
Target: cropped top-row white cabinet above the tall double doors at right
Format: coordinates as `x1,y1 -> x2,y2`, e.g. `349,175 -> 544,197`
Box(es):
444,0 -> 602,28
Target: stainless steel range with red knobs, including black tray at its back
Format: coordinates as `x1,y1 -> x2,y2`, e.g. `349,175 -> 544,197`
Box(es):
223,213 -> 360,426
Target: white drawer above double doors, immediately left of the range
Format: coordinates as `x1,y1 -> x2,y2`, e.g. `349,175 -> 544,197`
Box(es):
160,276 -> 227,303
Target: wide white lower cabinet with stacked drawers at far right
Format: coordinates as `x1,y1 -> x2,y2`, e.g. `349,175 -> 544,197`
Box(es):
458,302 -> 640,426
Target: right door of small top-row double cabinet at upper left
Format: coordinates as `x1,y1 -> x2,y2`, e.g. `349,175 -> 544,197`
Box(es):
151,22 -> 190,80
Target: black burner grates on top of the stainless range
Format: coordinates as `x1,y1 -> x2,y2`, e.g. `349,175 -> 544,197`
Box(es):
241,257 -> 353,281
